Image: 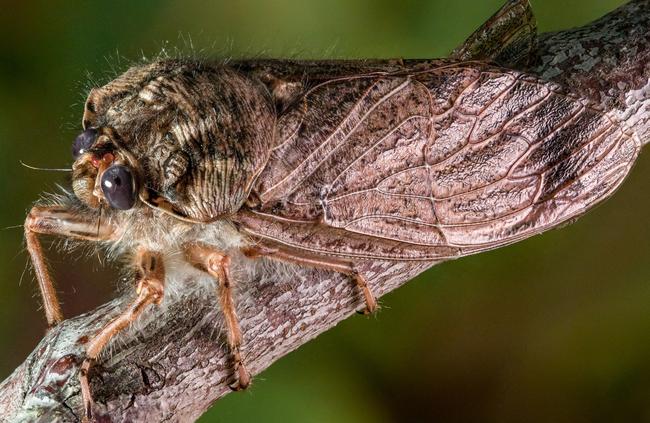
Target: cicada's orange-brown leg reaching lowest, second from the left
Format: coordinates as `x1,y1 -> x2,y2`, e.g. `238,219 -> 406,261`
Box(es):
79,249 -> 165,422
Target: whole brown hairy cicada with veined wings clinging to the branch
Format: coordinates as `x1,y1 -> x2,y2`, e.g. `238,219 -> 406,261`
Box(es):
25,2 -> 641,418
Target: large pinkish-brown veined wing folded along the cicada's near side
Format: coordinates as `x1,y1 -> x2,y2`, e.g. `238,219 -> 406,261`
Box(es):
238,64 -> 640,260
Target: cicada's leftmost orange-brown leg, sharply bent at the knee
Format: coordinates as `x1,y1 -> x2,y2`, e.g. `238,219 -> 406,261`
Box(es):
25,206 -> 114,327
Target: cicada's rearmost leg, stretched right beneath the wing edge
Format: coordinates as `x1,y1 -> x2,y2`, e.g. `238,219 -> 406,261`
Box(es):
242,246 -> 378,314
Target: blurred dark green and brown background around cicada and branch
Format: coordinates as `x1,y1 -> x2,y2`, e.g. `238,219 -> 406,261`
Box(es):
0,0 -> 650,423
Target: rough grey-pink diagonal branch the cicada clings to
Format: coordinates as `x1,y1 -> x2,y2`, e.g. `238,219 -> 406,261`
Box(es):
0,0 -> 650,422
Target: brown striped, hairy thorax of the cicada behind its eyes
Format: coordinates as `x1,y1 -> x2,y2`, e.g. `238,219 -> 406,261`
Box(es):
79,60 -> 275,222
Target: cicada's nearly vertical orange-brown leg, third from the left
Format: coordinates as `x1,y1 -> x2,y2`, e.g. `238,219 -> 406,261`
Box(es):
185,244 -> 251,390
